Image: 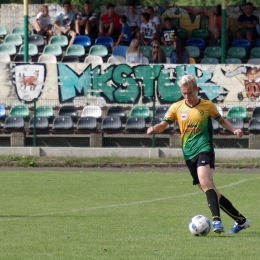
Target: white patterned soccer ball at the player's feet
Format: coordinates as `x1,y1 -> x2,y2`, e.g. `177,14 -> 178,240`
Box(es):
189,215 -> 211,236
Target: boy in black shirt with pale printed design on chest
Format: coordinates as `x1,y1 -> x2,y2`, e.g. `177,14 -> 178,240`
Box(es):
161,17 -> 178,46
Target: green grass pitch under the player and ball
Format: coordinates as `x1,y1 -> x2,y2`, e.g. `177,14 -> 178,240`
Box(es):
0,170 -> 260,260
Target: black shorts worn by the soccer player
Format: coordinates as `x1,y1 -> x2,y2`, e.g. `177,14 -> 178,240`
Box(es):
186,152 -> 215,185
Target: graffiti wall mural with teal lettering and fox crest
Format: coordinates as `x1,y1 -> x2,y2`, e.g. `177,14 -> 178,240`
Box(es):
0,63 -> 260,107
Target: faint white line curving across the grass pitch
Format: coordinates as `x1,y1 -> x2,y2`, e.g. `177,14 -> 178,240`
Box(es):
0,177 -> 260,222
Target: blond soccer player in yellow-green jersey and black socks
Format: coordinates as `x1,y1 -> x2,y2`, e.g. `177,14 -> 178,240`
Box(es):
147,75 -> 250,233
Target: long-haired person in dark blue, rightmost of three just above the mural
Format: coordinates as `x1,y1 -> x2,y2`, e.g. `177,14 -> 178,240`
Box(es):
170,40 -> 190,64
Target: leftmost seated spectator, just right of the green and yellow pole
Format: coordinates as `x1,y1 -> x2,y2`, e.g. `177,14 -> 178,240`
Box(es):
34,5 -> 53,43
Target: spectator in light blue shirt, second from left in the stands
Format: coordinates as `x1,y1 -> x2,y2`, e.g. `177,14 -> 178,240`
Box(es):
54,1 -> 76,45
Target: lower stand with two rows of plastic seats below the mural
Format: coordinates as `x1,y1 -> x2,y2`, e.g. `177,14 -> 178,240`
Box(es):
0,99 -> 260,149
